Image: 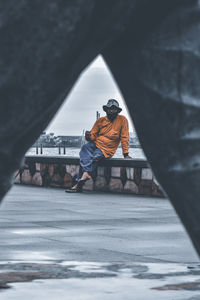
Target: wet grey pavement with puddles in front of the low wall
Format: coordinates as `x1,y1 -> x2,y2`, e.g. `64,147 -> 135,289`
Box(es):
0,186 -> 200,300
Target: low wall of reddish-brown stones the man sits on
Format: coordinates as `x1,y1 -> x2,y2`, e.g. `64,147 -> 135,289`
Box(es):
15,155 -> 163,196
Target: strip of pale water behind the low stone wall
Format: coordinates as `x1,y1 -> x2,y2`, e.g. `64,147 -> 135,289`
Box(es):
27,147 -> 146,160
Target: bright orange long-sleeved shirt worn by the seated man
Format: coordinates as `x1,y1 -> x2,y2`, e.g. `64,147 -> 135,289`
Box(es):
91,115 -> 129,157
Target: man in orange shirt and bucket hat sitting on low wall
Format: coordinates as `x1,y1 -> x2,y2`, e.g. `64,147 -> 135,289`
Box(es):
66,99 -> 131,193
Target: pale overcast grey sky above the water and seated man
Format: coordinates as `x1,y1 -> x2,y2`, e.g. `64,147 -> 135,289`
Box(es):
46,56 -> 133,135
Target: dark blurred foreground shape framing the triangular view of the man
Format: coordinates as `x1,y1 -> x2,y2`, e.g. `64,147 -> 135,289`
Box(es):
0,0 -> 200,253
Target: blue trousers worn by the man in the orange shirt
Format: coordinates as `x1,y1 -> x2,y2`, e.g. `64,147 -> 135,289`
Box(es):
76,142 -> 105,181
